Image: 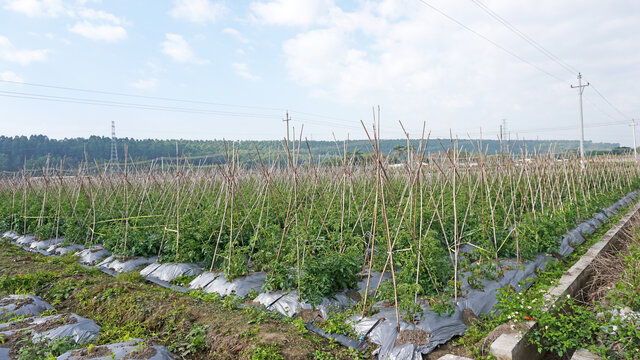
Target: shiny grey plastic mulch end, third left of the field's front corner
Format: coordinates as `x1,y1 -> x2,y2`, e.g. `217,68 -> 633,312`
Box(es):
189,272 -> 267,298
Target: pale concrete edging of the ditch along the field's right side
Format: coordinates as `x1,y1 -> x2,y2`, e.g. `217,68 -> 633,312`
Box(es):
490,198 -> 640,360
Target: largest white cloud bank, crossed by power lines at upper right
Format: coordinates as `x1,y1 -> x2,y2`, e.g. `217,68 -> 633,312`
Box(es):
272,0 -> 640,141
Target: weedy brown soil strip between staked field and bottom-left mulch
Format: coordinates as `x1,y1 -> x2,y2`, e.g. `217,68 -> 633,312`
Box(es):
0,242 -> 373,360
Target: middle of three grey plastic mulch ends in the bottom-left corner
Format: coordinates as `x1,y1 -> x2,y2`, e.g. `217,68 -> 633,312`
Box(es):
31,314 -> 100,344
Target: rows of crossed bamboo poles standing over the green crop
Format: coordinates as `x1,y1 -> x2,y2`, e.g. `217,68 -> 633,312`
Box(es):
0,123 -> 638,332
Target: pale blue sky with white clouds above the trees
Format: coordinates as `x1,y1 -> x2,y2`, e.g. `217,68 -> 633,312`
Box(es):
0,0 -> 640,146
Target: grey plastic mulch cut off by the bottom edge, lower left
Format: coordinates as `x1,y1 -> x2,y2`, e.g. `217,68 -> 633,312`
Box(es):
57,340 -> 176,360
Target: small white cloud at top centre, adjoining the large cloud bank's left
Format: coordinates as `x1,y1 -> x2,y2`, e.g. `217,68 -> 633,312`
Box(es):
250,0 -> 336,26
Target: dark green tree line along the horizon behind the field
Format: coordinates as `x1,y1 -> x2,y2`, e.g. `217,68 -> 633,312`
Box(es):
0,135 -> 620,171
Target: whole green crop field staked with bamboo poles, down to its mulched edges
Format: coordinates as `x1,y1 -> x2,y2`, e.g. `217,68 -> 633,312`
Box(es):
0,140 -> 640,358
